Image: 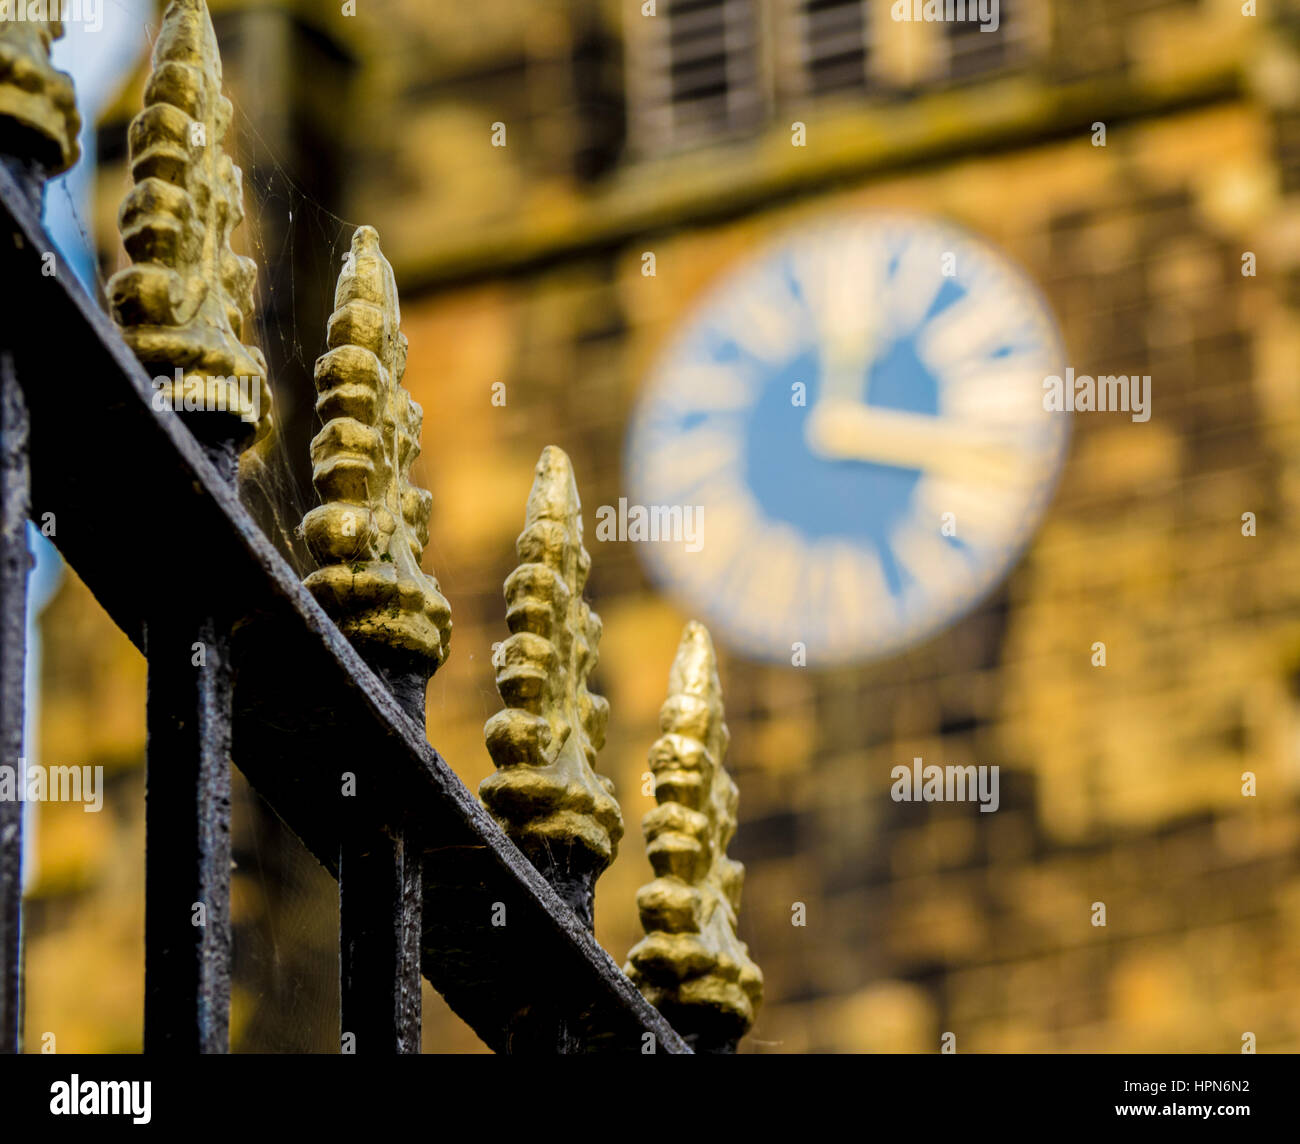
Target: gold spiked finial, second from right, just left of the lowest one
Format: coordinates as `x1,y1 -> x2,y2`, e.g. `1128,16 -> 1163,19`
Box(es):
478,445 -> 623,927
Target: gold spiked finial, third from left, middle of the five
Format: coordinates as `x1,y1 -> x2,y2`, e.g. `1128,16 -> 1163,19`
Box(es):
303,226 -> 451,681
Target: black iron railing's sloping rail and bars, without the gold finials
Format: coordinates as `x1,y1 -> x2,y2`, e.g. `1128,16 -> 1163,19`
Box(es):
0,144 -> 689,1053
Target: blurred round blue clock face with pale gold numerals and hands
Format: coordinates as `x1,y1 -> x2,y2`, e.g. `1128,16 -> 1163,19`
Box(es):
627,215 -> 1069,667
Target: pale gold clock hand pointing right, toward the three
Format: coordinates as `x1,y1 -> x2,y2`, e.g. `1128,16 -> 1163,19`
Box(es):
803,399 -> 1023,485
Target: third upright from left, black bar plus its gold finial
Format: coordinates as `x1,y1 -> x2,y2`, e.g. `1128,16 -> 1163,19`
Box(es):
303,226 -> 451,1053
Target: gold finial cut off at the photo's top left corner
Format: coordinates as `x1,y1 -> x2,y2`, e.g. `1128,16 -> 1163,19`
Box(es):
0,12 -> 81,176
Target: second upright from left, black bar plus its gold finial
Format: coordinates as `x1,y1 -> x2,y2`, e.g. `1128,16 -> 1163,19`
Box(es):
104,0 -> 270,1053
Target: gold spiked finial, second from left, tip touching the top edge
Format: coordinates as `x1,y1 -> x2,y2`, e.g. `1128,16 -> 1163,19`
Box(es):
107,0 -> 270,447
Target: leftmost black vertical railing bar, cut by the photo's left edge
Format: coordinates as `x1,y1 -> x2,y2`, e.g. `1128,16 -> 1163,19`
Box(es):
0,351 -> 31,1053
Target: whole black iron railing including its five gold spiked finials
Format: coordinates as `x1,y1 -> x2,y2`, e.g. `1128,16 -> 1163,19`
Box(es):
0,0 -> 762,1053
